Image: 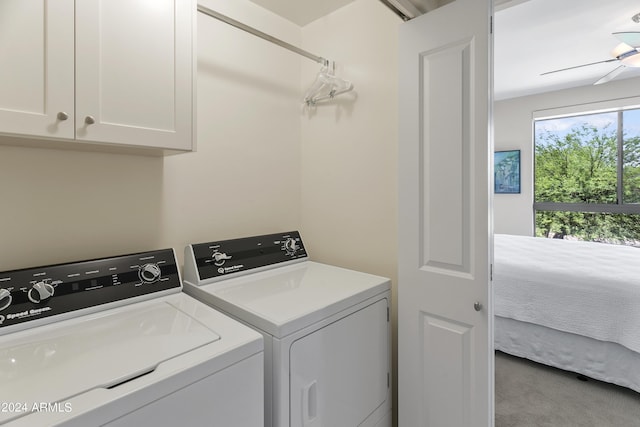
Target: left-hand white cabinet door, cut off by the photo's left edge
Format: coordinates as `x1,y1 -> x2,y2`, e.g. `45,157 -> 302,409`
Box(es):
0,0 -> 74,138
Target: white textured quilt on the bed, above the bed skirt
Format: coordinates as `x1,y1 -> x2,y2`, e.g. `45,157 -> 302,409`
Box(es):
493,234 -> 640,352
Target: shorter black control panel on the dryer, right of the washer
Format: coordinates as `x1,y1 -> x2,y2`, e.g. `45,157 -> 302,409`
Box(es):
192,231 -> 307,280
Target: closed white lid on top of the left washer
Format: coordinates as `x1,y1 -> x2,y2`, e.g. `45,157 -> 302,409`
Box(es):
0,301 -> 220,416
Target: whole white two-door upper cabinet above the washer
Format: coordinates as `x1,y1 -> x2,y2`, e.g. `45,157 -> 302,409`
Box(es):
0,0 -> 196,151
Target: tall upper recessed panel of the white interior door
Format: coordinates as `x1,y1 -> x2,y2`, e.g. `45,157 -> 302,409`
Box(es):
419,40 -> 472,273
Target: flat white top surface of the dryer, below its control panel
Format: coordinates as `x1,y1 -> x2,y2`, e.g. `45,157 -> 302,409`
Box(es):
200,261 -> 390,337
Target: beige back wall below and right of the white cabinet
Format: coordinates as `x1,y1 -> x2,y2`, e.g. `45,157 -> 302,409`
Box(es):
0,0 -> 301,271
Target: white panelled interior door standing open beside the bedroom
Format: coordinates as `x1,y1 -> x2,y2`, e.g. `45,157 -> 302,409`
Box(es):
398,0 -> 494,427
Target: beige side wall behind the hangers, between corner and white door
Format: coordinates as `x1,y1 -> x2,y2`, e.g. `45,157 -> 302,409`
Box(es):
301,0 -> 401,422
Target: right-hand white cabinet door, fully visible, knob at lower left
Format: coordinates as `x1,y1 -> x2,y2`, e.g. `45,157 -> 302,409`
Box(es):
76,0 -> 196,150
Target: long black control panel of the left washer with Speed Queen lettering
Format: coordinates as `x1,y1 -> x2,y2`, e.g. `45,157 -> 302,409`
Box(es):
0,249 -> 181,330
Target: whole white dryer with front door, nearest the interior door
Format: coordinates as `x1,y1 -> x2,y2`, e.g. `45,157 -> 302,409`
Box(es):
184,232 -> 391,427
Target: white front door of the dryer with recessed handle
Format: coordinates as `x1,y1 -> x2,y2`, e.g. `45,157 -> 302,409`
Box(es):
289,299 -> 389,427
